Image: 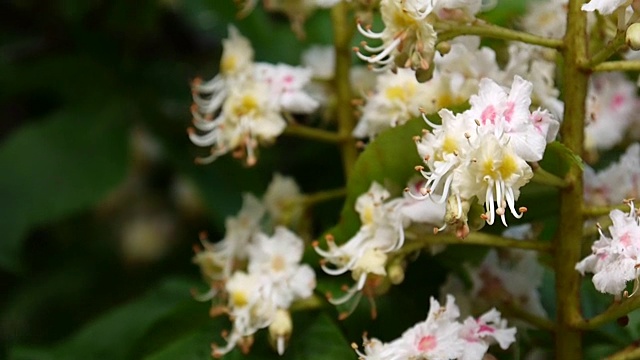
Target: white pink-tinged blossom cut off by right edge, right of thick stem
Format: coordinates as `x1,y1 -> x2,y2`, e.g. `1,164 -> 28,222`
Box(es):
576,201 -> 640,296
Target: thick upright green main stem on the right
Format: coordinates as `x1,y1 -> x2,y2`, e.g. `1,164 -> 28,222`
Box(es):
554,0 -> 589,359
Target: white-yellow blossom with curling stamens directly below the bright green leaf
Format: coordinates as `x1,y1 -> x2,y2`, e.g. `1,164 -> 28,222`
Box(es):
314,182 -> 444,317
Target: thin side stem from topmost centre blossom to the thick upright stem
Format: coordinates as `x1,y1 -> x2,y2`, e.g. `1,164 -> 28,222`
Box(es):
434,20 -> 563,49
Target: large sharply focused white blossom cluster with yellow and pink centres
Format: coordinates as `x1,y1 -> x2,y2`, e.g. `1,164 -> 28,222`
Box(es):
410,76 -> 559,231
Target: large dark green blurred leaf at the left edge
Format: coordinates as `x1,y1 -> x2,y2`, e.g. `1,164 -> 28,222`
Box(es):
0,102 -> 128,271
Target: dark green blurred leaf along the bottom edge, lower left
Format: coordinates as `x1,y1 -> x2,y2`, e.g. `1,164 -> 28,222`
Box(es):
11,279 -> 198,359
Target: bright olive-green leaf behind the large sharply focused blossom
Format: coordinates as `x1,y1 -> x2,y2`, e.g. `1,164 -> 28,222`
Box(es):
329,119 -> 428,242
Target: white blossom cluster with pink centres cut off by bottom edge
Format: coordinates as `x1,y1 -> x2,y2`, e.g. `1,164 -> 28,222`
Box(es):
353,295 -> 516,360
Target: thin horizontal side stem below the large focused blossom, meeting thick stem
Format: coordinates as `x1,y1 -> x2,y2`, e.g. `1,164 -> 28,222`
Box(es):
399,232 -> 551,253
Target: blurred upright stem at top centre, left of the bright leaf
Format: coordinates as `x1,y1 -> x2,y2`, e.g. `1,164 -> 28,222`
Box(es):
331,1 -> 358,179
